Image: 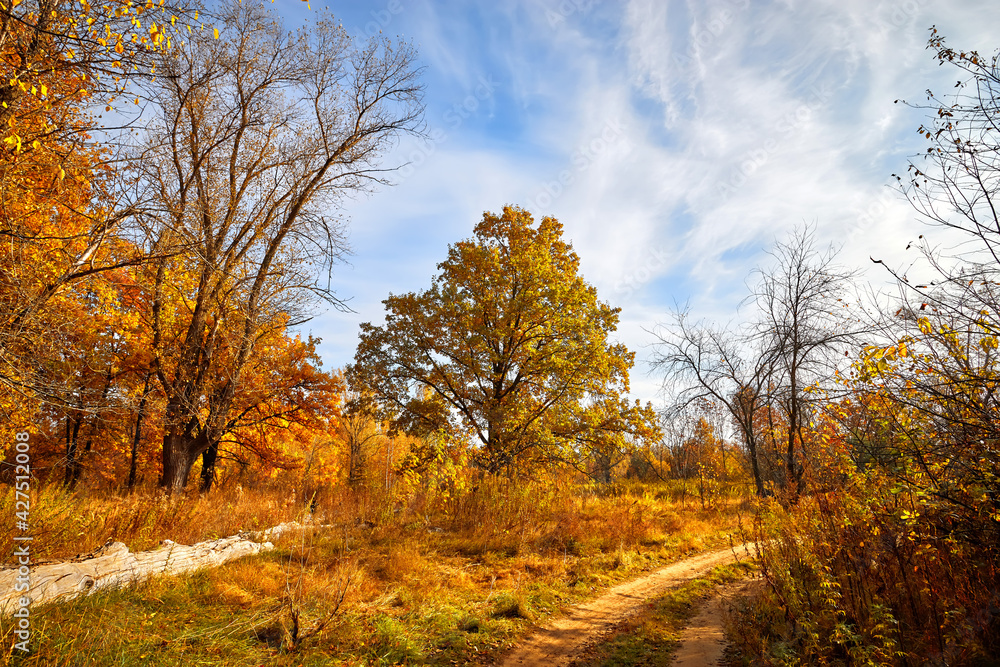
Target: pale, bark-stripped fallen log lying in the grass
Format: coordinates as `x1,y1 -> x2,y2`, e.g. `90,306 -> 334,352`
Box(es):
0,524 -> 278,614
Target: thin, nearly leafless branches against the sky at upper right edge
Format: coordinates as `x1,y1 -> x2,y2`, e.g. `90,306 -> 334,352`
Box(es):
888,28 -> 1000,368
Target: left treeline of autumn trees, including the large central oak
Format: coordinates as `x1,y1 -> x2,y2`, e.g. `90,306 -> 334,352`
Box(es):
0,0 -> 669,497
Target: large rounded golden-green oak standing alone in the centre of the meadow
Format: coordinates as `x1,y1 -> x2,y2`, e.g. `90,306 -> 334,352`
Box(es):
347,207 -> 657,473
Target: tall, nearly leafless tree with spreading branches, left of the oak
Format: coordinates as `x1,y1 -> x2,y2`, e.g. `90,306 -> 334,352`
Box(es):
135,1 -> 421,490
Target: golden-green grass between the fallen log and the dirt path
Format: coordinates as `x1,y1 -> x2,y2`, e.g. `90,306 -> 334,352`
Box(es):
0,482 -> 752,667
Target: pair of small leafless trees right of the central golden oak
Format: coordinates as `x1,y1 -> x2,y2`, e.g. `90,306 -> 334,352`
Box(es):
652,228 -> 858,495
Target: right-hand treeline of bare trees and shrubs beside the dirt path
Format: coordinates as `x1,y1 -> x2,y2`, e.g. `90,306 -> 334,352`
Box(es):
658,31 -> 1000,665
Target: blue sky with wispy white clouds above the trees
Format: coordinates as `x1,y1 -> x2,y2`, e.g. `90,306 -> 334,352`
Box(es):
275,0 -> 1000,402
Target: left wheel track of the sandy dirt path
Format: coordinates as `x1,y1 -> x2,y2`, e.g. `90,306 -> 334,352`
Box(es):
500,544 -> 752,667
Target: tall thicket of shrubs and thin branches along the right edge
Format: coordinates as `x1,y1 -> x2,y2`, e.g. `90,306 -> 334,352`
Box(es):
724,30 -> 1000,665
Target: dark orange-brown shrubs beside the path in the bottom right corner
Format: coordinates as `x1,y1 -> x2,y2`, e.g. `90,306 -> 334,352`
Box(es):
743,394 -> 998,664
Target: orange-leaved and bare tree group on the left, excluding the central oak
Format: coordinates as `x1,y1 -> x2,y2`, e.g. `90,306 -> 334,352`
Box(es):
0,0 -> 422,490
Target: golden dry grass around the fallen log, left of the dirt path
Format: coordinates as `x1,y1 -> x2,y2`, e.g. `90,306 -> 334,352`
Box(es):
0,480 -> 752,665
